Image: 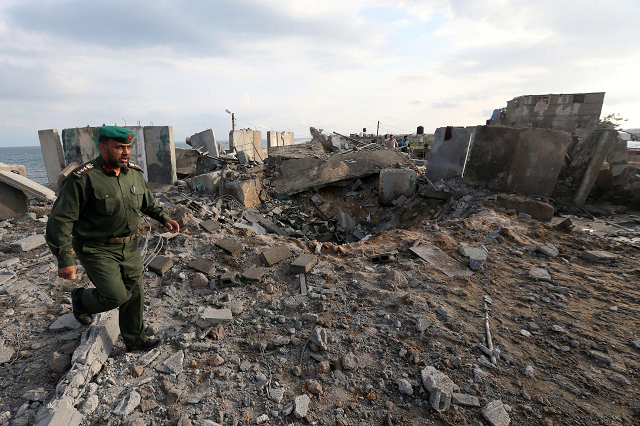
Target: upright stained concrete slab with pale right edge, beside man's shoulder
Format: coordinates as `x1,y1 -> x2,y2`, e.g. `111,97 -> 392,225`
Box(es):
144,126 -> 178,184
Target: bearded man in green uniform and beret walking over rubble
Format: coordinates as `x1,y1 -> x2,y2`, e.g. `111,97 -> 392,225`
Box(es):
46,126 -> 180,351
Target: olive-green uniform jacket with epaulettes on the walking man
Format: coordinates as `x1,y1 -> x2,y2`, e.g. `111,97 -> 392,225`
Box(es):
46,157 -> 170,268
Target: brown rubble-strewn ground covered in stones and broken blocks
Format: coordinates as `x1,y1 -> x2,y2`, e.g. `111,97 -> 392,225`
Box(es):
0,182 -> 640,425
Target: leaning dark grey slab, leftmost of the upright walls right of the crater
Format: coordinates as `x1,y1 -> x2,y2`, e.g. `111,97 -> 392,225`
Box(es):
427,127 -> 473,182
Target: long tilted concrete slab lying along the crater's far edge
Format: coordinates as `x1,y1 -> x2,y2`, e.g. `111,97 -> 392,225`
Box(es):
271,145 -> 411,198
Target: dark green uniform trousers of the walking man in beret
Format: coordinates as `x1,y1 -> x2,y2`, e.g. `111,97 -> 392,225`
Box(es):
73,237 -> 147,346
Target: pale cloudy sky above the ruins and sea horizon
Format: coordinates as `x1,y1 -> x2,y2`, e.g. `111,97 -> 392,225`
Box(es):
0,0 -> 640,146
